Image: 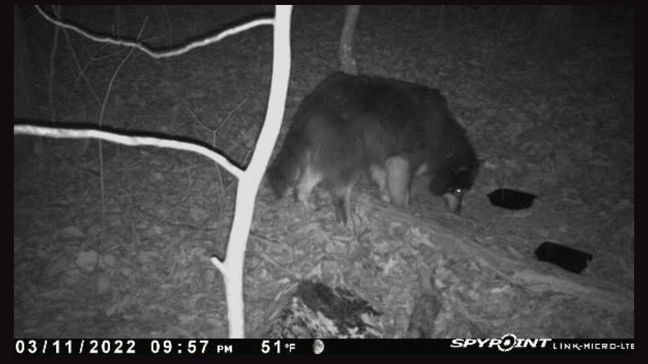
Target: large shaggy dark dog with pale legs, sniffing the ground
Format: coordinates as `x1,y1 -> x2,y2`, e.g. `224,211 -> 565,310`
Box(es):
268,73 -> 478,223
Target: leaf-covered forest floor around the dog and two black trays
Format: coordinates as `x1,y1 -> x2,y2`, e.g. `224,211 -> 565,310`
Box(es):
13,6 -> 635,338
